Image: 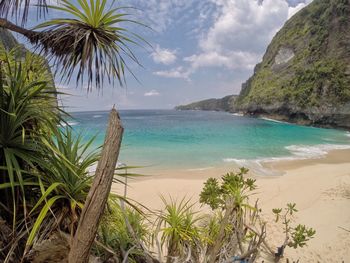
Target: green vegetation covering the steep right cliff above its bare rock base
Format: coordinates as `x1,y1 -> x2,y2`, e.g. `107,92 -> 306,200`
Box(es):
238,0 -> 350,114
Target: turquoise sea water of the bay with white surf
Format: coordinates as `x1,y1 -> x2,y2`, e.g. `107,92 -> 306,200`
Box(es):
69,110 -> 350,169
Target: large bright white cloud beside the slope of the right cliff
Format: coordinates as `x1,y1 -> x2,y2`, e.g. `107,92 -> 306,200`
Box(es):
184,0 -> 311,73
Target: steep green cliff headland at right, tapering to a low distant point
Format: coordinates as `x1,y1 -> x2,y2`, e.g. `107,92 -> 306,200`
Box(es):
176,0 -> 350,129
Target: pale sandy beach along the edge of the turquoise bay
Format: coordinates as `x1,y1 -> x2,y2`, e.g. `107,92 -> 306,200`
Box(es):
113,150 -> 350,262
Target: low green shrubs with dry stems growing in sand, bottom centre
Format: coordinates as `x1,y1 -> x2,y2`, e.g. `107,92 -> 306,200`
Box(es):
156,168 -> 315,263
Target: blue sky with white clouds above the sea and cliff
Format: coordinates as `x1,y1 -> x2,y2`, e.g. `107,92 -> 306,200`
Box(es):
23,0 -> 312,111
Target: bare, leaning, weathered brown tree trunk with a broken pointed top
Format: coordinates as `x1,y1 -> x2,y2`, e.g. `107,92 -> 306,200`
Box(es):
69,109 -> 124,263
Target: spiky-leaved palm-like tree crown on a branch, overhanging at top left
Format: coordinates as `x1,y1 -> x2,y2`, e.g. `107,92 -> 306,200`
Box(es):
0,0 -> 145,88
